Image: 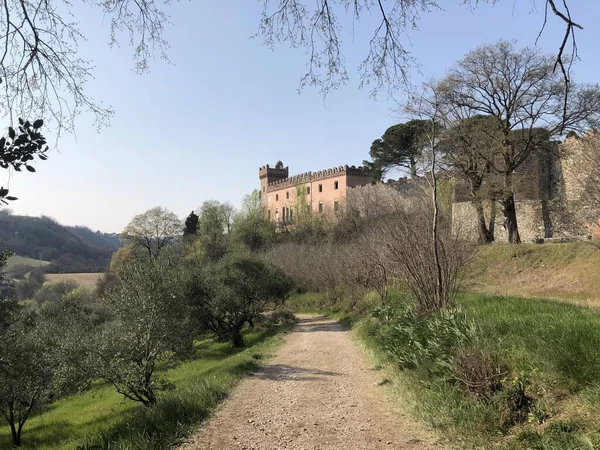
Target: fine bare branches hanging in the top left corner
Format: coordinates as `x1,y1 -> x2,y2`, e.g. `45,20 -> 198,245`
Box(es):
0,0 -> 171,134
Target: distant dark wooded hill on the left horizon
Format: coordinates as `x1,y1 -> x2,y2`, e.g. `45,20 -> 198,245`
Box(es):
0,214 -> 120,273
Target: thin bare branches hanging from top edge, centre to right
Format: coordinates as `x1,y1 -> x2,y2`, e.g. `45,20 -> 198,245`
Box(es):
258,0 -> 583,93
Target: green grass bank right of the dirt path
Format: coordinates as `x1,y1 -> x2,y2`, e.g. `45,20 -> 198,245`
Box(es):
359,294 -> 600,450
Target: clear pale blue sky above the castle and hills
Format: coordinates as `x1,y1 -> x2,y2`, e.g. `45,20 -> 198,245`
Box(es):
0,0 -> 600,232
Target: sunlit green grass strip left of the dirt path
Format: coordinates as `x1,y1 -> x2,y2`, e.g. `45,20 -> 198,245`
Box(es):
0,327 -> 290,450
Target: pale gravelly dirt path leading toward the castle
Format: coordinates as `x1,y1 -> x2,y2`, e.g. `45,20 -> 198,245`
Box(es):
181,317 -> 439,450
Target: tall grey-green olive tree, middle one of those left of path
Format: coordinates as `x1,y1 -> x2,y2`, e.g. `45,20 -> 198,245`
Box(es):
92,255 -> 192,406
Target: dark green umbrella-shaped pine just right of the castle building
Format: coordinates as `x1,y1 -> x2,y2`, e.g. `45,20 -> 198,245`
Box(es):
364,119 -> 428,179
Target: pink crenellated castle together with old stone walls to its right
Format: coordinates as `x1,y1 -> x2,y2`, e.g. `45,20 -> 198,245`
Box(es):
259,134 -> 600,242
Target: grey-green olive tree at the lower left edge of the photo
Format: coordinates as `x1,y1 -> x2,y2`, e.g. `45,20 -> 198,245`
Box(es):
0,292 -> 91,446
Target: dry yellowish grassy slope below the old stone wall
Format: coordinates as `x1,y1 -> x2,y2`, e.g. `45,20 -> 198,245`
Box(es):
465,242 -> 600,307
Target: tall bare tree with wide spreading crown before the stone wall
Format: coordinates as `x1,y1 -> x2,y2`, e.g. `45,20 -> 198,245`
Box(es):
436,41 -> 600,243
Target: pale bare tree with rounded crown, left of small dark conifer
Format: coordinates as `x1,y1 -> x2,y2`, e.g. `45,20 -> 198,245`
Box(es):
121,206 -> 181,259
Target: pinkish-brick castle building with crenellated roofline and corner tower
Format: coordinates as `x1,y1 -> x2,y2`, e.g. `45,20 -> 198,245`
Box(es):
258,162 -> 371,222
